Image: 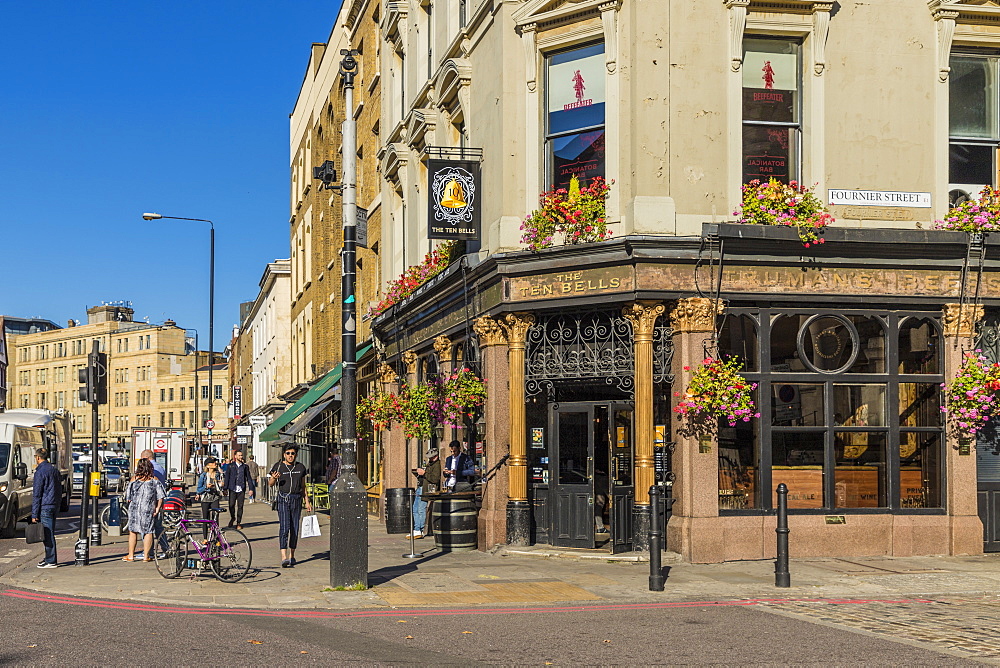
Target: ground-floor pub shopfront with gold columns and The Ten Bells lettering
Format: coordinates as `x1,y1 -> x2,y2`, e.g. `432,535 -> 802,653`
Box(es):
376,228 -> 1000,561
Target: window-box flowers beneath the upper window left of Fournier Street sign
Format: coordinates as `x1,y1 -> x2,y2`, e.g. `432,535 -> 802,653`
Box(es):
733,178 -> 834,248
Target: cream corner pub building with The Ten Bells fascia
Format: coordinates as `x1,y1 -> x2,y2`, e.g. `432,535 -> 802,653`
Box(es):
369,0 -> 1000,562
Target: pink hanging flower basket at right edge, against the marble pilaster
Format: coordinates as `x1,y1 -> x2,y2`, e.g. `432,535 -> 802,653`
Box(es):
941,349 -> 1000,439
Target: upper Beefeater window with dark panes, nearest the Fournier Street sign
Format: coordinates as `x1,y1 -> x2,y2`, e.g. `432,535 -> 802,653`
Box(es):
742,39 -> 802,183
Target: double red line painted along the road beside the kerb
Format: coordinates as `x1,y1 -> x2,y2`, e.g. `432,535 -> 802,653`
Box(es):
0,589 -> 934,619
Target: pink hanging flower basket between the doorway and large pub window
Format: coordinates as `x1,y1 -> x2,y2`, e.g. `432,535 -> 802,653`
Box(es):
674,357 -> 760,427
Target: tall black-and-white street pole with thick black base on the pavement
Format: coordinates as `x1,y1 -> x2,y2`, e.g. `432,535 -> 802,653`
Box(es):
326,49 -> 368,587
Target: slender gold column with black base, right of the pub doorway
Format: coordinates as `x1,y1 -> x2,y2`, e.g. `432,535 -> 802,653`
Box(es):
622,301 -> 665,550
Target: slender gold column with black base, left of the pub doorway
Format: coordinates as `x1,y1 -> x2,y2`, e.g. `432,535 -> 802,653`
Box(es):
501,313 -> 535,545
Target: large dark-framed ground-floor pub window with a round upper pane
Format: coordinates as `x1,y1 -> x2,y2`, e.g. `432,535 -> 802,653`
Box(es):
718,309 -> 944,511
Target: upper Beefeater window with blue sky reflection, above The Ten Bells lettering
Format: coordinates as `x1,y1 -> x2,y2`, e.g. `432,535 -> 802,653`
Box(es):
545,43 -> 606,188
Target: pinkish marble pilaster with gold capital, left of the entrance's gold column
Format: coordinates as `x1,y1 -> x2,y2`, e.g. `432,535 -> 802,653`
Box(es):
473,316 -> 510,550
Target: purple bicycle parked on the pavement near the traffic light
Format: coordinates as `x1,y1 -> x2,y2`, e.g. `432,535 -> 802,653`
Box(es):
155,508 -> 253,582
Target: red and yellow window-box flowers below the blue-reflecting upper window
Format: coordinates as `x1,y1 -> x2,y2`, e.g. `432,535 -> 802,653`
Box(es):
521,176 -> 612,251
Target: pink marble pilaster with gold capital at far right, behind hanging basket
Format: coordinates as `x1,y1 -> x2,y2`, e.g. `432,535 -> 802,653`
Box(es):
941,304 -> 983,554
